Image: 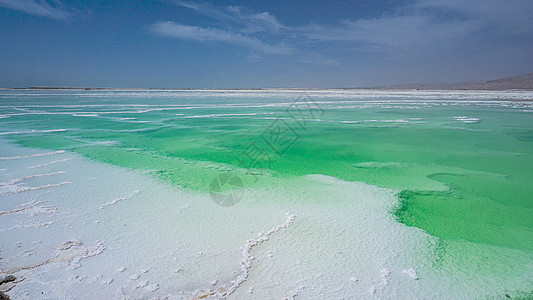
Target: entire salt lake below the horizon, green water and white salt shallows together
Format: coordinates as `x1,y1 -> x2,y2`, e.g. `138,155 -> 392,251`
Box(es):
0,90 -> 533,299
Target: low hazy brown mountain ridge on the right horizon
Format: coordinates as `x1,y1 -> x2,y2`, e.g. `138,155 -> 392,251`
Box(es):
381,73 -> 533,90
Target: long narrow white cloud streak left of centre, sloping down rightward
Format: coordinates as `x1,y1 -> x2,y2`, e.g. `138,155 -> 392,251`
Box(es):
150,21 -> 292,54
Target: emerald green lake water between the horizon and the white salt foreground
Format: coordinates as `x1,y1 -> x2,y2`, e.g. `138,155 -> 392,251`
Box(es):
0,91 -> 533,250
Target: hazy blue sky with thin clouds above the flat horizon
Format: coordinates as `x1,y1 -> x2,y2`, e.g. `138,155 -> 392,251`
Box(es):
0,0 -> 533,88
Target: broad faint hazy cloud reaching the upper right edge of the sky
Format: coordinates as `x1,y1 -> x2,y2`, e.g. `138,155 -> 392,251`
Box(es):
296,0 -> 533,51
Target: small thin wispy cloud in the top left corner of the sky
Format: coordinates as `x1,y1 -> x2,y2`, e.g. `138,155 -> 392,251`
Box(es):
0,0 -> 74,21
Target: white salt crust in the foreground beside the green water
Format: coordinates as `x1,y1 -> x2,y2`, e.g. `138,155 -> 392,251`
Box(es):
0,140 -> 533,299
